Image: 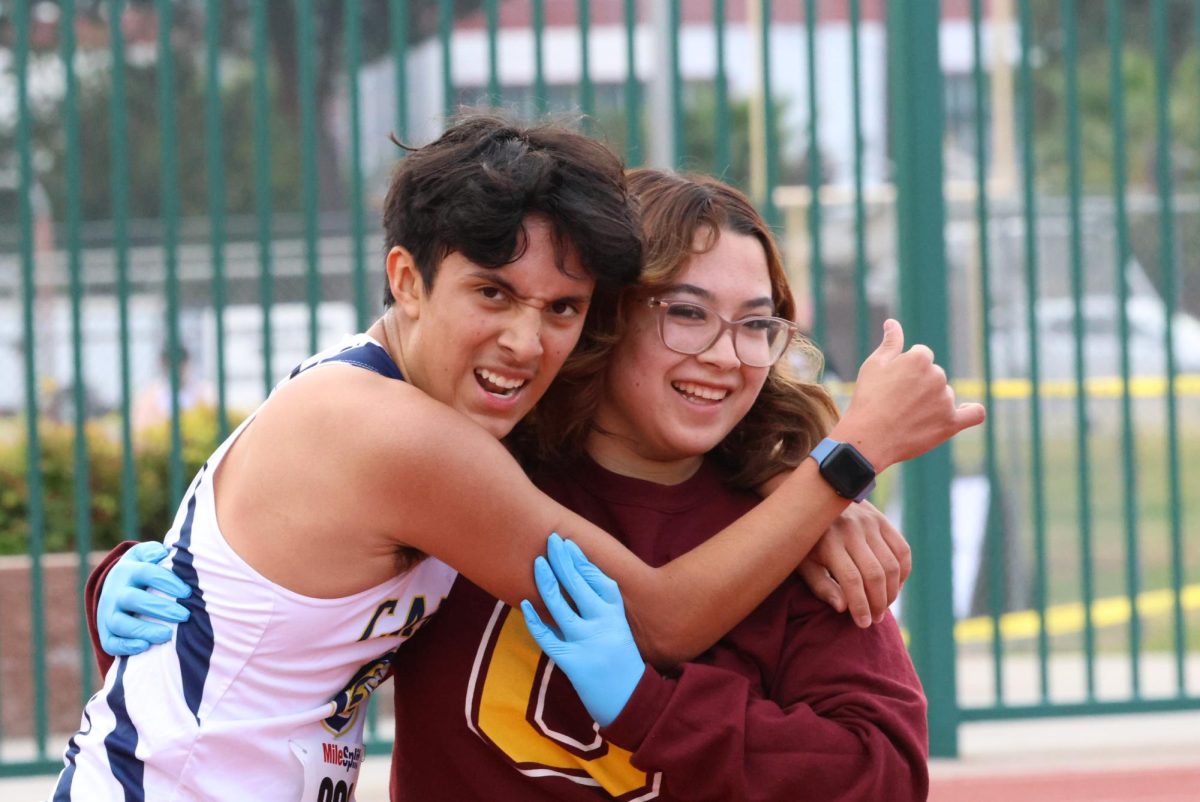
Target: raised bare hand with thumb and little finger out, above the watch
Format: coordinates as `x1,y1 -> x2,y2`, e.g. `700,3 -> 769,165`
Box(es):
830,319 -> 986,472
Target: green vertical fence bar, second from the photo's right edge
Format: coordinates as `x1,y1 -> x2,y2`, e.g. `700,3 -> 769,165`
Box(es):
1108,0 -> 1141,698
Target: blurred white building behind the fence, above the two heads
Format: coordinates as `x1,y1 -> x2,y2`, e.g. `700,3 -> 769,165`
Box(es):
337,0 -> 1018,192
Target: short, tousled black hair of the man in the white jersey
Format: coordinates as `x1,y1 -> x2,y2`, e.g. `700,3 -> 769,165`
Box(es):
383,113 -> 642,306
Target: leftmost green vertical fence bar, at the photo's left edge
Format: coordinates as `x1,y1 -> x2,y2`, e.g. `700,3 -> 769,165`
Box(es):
13,0 -> 49,760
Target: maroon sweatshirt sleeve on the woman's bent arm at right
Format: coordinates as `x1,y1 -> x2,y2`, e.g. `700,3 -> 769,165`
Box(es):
602,600 -> 929,802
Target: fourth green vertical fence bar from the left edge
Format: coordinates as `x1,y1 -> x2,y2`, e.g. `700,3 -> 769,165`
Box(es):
156,0 -> 184,509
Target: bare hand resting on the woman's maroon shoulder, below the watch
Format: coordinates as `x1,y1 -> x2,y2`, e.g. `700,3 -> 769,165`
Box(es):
797,501 -> 912,628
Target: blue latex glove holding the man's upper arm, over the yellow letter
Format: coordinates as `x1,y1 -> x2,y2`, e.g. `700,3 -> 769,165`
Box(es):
521,534 -> 646,726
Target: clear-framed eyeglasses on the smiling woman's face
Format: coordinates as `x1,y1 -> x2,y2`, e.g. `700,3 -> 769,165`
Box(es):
647,298 -> 799,367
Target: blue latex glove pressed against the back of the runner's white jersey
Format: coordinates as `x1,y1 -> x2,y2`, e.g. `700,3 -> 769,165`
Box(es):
96,541 -> 192,657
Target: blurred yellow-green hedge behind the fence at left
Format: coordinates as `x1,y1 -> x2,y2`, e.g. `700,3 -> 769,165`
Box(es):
0,407 -> 238,555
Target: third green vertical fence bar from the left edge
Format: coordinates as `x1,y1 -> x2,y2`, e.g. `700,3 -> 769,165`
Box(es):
108,0 -> 138,540
